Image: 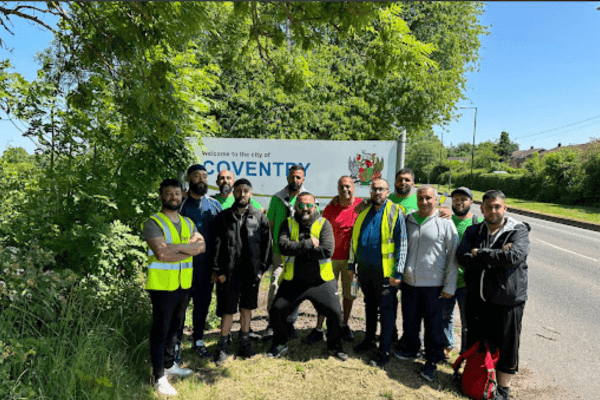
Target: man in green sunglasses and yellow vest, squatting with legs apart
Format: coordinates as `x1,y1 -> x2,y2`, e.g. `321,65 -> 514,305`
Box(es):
267,192 -> 348,361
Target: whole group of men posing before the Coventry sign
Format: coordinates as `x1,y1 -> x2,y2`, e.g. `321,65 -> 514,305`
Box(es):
144,164 -> 529,400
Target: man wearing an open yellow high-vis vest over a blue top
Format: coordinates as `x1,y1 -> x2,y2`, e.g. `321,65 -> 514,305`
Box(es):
348,179 -> 406,367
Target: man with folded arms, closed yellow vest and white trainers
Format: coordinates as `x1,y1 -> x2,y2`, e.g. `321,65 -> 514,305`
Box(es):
143,179 -> 206,396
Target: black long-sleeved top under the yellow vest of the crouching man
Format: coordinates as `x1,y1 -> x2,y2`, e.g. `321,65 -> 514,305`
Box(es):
279,210 -> 335,285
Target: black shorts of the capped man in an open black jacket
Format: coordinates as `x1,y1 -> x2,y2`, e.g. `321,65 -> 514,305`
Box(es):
217,275 -> 260,316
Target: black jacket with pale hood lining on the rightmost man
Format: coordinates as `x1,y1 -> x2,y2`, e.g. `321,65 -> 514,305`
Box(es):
456,217 -> 531,306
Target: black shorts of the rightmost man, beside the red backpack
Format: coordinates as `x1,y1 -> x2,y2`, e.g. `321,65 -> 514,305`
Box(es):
478,303 -> 525,375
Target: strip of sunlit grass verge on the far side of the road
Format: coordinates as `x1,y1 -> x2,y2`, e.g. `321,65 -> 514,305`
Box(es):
436,185 -> 600,224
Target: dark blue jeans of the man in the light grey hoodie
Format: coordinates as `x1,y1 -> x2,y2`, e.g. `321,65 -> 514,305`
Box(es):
401,282 -> 445,364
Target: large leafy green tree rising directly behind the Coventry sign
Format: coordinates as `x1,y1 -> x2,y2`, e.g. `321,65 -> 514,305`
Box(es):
199,3 -> 485,140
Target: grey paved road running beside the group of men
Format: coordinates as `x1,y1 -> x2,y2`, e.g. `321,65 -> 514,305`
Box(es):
473,205 -> 600,400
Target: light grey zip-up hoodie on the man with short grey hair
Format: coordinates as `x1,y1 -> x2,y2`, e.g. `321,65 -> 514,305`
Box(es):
402,210 -> 458,295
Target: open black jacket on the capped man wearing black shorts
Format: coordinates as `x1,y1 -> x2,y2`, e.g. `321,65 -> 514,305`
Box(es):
212,207 -> 272,278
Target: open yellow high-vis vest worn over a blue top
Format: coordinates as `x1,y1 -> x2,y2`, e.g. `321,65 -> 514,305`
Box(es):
350,201 -> 405,278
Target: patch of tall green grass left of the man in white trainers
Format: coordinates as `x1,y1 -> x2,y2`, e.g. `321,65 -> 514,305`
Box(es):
0,247 -> 152,400
